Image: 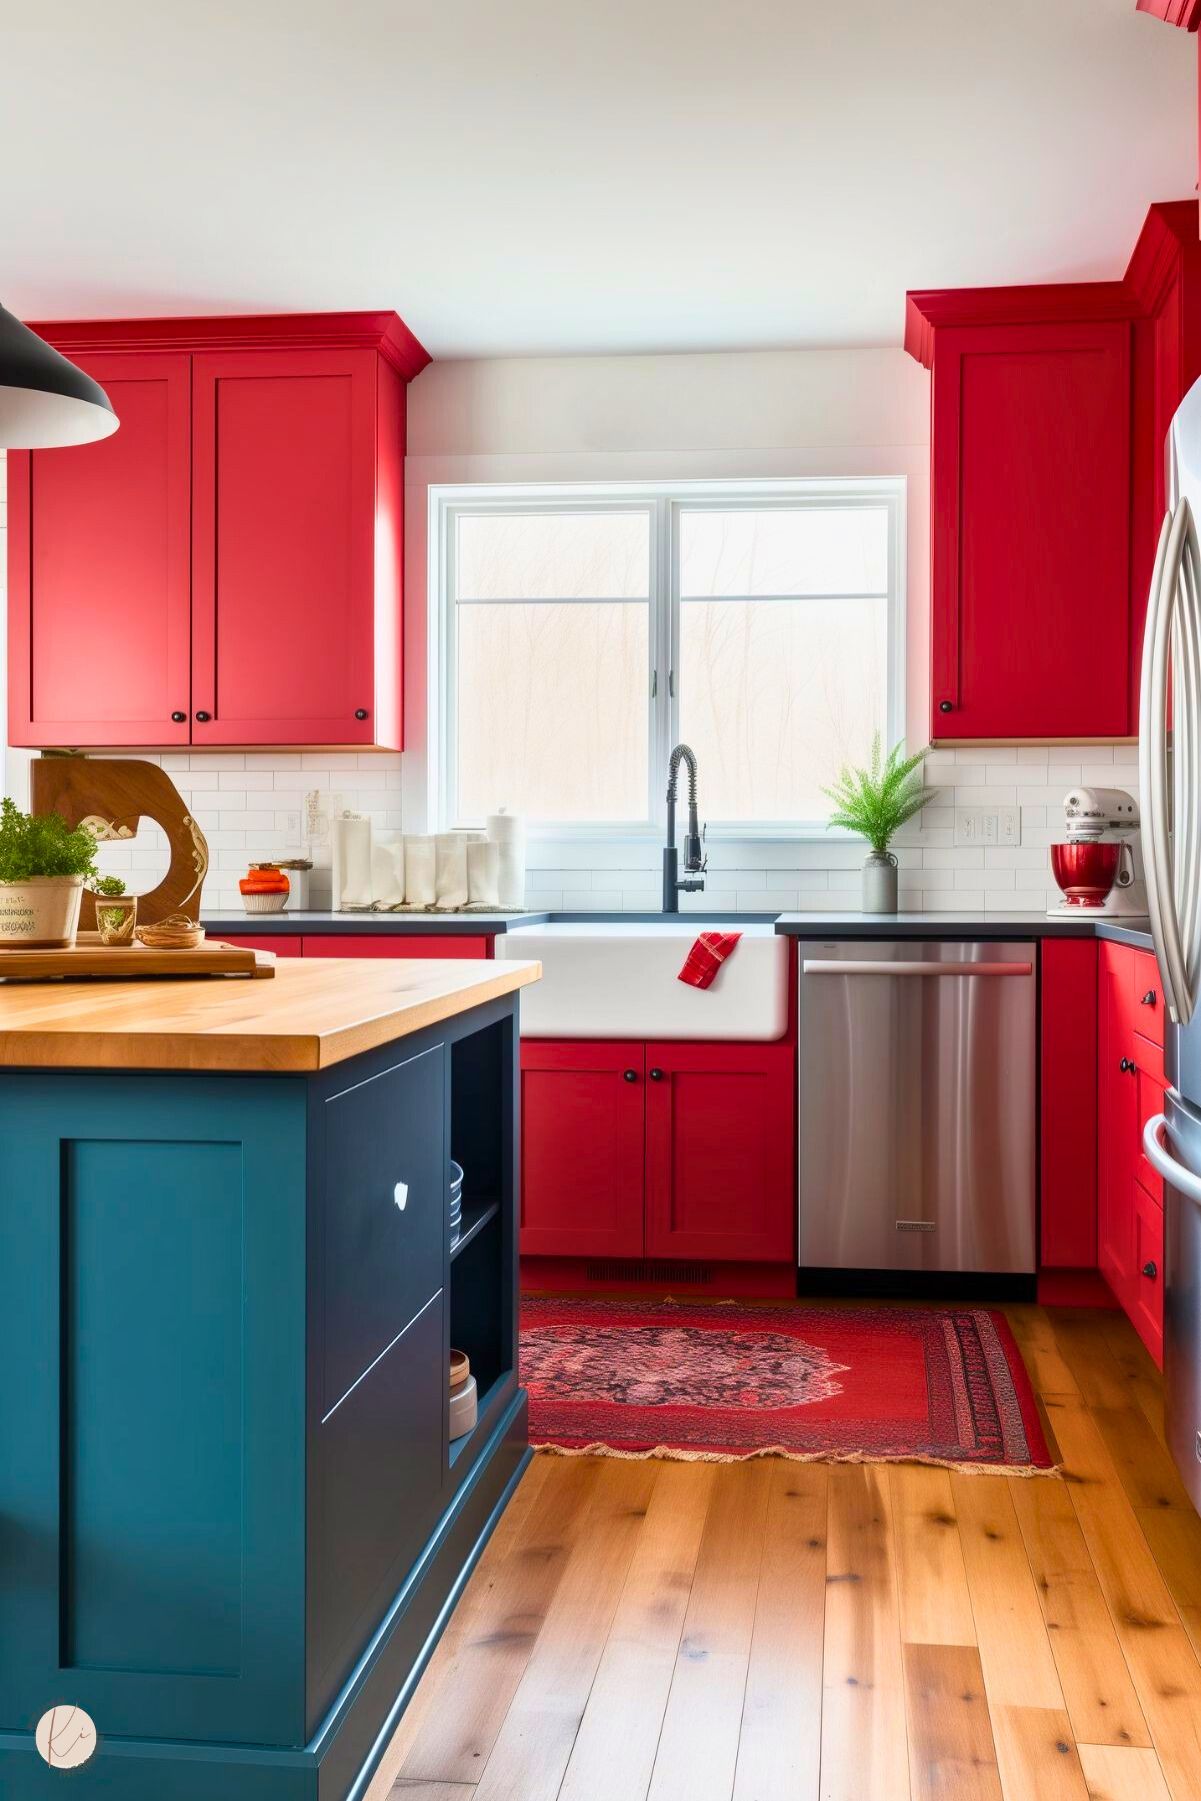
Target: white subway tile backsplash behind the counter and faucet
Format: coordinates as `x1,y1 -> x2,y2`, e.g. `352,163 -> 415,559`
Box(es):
9,744 -> 1101,915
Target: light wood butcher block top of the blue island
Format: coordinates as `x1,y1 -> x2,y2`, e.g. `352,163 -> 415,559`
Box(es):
0,958 -> 542,1075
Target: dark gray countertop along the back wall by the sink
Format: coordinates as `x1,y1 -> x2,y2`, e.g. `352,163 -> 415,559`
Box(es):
203,910 -> 1152,951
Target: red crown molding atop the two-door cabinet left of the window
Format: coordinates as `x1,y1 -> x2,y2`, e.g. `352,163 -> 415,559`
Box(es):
31,312 -> 430,382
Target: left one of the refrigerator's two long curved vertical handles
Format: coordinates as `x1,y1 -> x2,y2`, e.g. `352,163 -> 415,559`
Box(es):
1138,501 -> 1192,1025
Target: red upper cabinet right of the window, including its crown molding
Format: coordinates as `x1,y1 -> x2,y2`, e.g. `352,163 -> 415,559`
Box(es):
906,200 -> 1201,744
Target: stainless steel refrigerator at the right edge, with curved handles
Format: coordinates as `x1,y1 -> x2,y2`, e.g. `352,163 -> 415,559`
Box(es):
1138,382 -> 1201,1509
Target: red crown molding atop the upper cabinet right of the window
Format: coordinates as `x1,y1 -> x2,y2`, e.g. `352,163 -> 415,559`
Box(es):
906,199 -> 1201,369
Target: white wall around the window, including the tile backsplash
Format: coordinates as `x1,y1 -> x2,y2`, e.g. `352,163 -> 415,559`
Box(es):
0,349 -> 1136,910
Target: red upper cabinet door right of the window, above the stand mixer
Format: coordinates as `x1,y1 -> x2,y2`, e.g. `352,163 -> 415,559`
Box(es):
931,321 -> 1134,740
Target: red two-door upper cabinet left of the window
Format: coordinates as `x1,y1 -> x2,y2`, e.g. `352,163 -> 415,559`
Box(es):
9,313 -> 429,749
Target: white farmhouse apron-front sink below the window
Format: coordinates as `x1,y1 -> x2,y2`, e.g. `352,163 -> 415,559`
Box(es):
495,915 -> 789,1039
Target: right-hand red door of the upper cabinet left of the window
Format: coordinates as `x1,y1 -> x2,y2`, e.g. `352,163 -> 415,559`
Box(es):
193,349 -> 383,744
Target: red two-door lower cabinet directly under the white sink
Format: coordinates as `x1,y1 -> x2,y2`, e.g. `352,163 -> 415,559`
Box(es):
520,1039 -> 796,1266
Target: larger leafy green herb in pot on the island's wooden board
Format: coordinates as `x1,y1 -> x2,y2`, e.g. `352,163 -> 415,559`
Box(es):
0,800 -> 95,951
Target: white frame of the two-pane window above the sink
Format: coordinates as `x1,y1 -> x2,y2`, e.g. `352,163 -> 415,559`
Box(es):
427,475 -> 906,841
